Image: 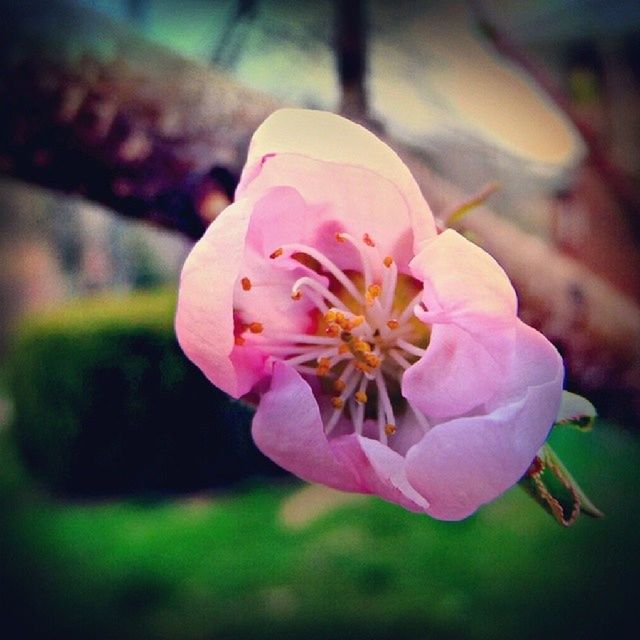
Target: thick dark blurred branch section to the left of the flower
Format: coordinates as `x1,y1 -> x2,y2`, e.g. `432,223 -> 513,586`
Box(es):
0,0 -> 278,238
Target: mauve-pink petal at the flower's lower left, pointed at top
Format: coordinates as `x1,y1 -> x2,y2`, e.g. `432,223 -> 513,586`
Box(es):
252,362 -> 359,491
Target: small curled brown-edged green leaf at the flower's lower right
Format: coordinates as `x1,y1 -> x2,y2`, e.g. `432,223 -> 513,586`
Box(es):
520,444 -> 604,527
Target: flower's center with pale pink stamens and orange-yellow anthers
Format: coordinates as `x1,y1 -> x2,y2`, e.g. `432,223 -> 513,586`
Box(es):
236,233 -> 430,444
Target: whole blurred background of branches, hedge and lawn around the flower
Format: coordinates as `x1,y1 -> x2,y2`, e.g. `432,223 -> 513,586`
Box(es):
0,0 -> 640,639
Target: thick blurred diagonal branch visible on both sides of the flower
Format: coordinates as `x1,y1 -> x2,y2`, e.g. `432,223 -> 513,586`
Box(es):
0,0 -> 640,418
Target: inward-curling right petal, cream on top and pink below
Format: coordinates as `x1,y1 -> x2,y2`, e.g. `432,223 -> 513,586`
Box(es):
402,230 -> 517,418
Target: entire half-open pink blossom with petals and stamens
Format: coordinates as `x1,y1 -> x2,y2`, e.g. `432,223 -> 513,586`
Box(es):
176,109 -> 563,520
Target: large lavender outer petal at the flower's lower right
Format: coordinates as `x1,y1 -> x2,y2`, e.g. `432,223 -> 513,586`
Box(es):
407,322 -> 563,520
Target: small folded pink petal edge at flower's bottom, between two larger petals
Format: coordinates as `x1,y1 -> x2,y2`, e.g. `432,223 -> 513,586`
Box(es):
331,433 -> 429,511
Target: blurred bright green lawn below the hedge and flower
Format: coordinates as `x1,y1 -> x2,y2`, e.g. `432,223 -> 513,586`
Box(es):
0,425 -> 640,640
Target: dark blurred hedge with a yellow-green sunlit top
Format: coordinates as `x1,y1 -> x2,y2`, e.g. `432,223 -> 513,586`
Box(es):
8,291 -> 275,494
